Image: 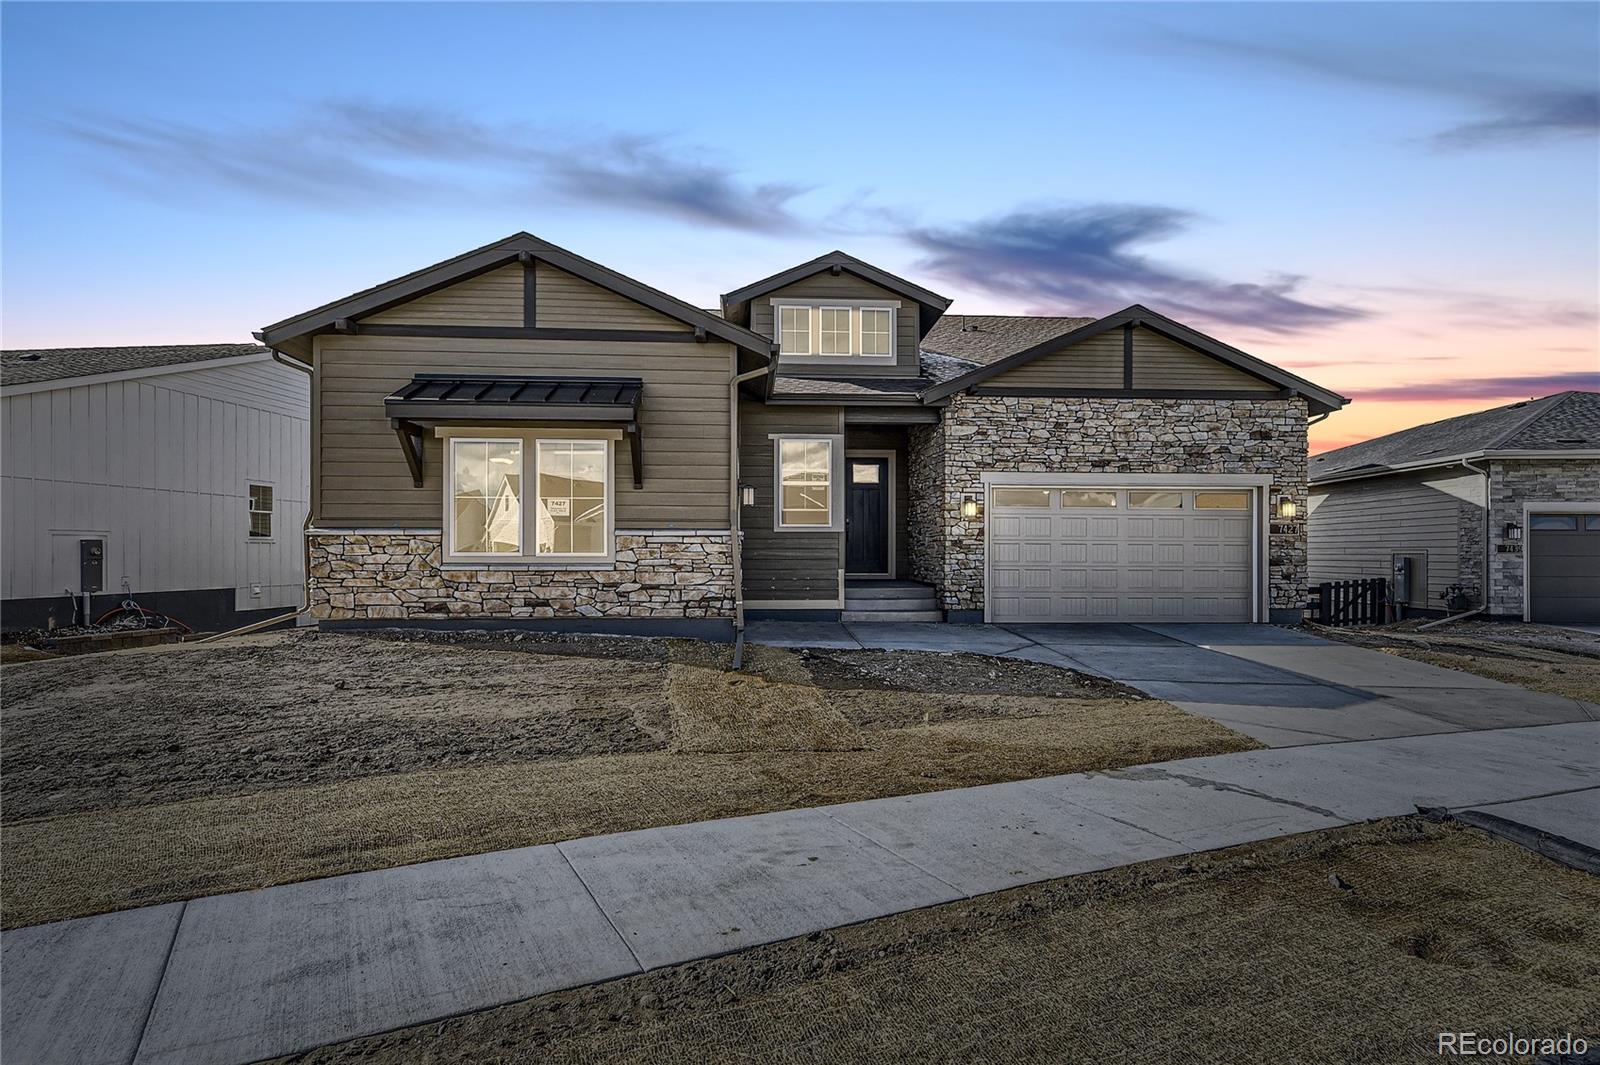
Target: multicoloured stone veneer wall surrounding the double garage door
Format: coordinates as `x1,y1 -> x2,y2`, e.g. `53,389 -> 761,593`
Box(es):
910,393 -> 1307,611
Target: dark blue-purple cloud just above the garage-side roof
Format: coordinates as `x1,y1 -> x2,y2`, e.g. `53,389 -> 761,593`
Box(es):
906,203 -> 1366,333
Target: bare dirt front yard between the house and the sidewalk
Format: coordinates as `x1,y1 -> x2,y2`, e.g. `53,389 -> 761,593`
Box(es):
0,633 -> 1254,927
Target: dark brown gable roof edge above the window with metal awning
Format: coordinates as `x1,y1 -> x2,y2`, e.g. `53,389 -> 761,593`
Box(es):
256,232 -> 776,360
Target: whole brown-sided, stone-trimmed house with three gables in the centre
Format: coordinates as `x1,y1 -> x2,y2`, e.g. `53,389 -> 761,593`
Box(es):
258,233 -> 1346,635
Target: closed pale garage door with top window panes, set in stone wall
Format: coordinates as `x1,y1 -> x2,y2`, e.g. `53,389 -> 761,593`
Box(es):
989,486 -> 1253,622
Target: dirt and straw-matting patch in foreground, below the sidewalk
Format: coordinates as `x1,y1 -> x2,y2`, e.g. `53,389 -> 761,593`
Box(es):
281,819 -> 1600,1065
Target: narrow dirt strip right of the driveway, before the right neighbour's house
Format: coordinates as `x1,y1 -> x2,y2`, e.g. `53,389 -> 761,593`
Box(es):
1309,620 -> 1600,704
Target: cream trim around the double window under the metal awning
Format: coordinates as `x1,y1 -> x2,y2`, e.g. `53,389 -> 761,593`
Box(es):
434,425 -> 622,569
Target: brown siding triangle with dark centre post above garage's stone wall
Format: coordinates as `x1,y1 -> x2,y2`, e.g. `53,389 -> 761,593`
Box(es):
981,328 -> 1278,392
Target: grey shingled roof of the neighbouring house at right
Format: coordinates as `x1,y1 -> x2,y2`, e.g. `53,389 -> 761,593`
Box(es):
1310,392 -> 1600,485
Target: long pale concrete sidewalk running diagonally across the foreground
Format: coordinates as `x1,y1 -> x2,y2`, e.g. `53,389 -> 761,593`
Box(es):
0,723 -> 1600,1065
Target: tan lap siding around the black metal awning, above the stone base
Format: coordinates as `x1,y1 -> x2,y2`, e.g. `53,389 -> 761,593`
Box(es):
314,334 -> 733,529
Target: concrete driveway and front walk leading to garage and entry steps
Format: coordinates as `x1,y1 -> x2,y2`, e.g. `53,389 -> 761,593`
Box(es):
747,622 -> 1600,747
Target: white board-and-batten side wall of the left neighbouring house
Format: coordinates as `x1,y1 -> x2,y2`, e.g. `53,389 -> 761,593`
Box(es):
0,358 -> 309,611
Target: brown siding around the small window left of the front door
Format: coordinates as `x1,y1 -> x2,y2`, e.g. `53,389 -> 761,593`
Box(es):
739,401 -> 845,600
